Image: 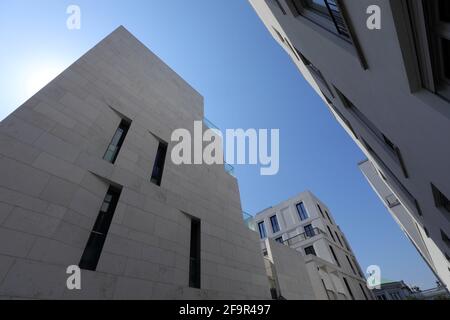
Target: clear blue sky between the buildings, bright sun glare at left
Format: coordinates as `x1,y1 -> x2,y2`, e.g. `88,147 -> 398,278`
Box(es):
0,0 -> 435,289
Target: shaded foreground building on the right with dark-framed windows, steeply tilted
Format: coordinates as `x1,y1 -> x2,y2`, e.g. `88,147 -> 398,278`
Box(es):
250,0 -> 450,286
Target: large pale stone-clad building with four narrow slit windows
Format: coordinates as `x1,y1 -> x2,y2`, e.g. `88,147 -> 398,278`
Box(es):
0,27 -> 270,299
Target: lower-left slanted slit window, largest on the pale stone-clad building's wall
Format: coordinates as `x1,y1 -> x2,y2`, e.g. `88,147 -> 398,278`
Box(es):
79,186 -> 122,271
